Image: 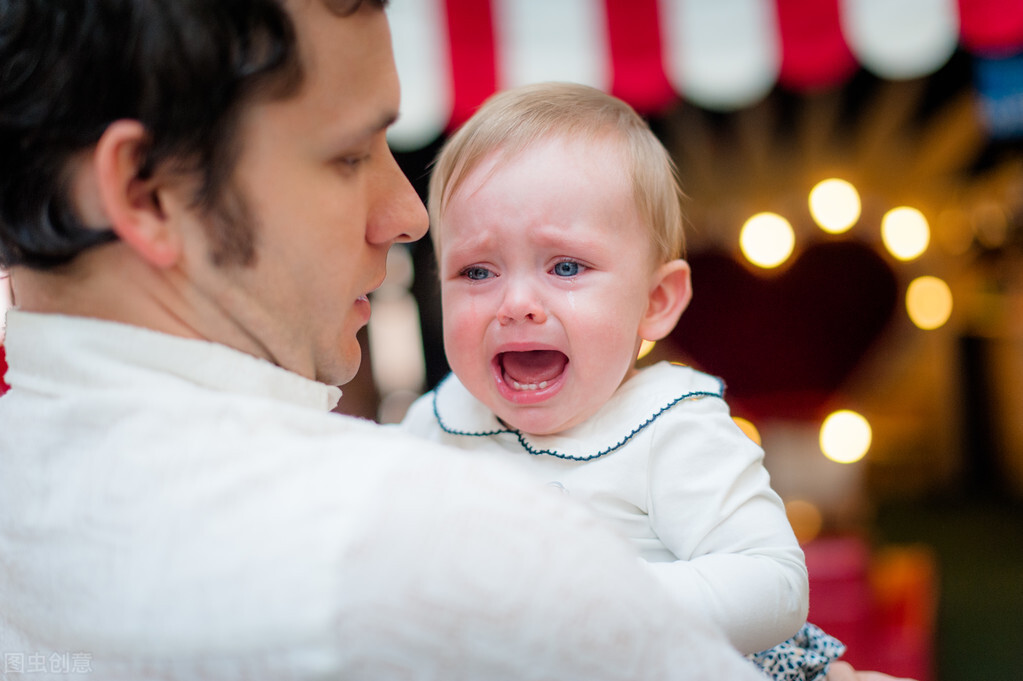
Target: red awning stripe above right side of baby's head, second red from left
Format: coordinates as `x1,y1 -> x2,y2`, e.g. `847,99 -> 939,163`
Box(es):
605,0 -> 675,114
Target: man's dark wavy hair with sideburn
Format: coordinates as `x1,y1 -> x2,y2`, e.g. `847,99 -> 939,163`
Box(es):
0,0 -> 386,269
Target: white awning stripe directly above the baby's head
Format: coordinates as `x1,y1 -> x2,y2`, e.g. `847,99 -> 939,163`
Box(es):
493,0 -> 611,90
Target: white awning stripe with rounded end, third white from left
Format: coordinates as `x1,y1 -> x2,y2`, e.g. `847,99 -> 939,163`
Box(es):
660,0 -> 782,109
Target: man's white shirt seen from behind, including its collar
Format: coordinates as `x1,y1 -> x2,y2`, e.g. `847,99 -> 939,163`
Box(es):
0,312 -> 760,681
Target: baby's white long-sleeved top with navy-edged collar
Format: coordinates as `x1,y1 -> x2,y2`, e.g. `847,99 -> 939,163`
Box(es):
403,363 -> 808,652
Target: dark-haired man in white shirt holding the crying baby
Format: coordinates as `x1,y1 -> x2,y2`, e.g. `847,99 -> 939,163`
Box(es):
0,0 -> 758,680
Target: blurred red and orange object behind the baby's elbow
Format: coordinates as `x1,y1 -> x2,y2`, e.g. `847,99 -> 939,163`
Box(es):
803,536 -> 938,681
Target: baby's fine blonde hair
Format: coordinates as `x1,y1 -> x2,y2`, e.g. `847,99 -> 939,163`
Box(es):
429,83 -> 685,262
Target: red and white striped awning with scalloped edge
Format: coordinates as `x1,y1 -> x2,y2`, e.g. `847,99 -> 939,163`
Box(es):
389,0 -> 1023,149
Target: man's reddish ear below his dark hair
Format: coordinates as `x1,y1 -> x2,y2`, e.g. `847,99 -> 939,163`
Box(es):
93,121 -> 181,268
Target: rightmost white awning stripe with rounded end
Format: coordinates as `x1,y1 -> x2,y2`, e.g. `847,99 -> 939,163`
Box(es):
841,0 -> 960,80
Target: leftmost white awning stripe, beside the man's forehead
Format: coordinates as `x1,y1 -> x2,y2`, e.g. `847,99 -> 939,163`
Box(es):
388,0 -> 453,150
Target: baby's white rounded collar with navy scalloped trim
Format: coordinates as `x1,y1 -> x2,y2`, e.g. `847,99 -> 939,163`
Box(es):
434,362 -> 724,461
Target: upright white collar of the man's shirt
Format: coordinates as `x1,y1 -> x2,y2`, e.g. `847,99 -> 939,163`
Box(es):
4,310 -> 341,411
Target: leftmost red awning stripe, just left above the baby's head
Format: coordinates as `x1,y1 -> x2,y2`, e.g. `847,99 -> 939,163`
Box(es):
445,0 -> 497,131
